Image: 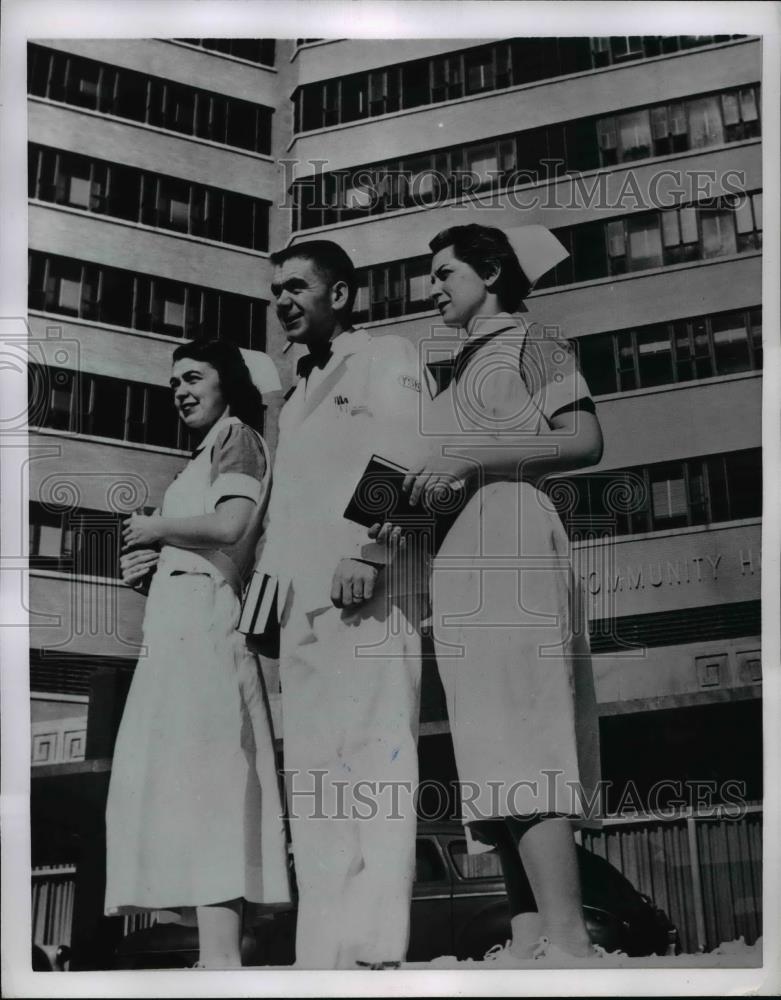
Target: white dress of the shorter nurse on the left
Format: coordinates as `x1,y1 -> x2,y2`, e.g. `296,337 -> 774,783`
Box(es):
105,418 -> 290,915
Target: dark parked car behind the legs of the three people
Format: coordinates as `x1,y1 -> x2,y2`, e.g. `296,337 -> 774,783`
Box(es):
116,823 -> 677,969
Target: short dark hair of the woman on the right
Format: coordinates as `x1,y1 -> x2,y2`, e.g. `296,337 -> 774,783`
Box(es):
429,222 -> 531,312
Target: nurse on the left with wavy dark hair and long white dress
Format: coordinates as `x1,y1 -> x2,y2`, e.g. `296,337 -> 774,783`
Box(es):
105,341 -> 290,968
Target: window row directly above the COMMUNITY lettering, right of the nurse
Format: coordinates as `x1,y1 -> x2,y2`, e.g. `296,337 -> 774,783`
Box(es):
548,448 -> 762,539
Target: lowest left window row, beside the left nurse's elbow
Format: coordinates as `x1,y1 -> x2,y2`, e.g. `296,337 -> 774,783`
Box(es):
29,501 -> 122,577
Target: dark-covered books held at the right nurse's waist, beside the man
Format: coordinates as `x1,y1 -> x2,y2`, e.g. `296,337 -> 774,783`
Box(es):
344,455 -> 467,551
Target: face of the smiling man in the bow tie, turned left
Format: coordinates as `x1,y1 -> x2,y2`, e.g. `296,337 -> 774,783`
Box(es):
271,257 -> 337,346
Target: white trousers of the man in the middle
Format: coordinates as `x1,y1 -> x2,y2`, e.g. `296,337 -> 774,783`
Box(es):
280,591 -> 421,969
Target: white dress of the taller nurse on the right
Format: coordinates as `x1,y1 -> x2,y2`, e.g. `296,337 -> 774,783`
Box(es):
427,315 -> 599,846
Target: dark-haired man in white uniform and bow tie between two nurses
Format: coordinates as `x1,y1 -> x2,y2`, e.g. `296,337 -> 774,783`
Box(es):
260,241 -> 425,969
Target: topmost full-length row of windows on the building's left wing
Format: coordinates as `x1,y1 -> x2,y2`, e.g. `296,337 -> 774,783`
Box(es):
27,45 -> 273,154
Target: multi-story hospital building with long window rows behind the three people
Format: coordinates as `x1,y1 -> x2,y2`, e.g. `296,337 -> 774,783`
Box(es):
29,36 -> 762,964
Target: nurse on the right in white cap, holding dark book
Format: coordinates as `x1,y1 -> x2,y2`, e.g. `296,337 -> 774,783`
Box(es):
396,225 -> 602,964
